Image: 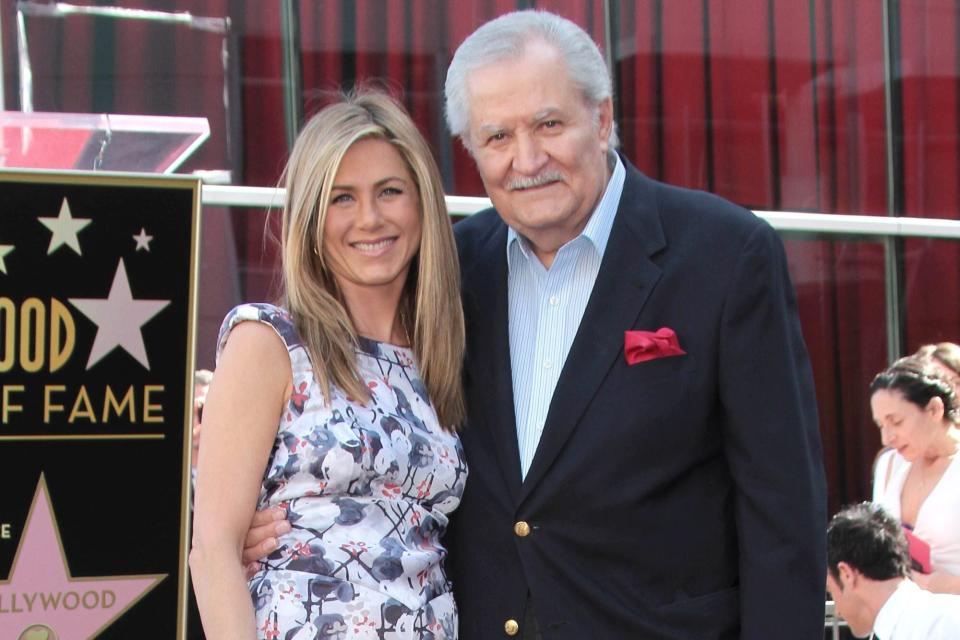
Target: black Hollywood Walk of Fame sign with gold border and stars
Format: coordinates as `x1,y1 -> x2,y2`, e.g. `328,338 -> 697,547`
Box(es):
0,171 -> 200,640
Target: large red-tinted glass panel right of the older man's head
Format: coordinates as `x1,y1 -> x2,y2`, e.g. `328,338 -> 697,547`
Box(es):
615,0 -> 886,213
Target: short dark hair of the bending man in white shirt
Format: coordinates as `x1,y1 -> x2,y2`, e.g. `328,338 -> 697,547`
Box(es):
827,502 -> 910,582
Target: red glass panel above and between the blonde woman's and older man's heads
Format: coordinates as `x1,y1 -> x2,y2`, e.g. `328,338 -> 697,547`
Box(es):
300,0 -> 524,195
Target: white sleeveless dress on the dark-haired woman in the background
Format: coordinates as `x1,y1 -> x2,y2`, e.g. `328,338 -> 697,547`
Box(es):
873,449 -> 960,576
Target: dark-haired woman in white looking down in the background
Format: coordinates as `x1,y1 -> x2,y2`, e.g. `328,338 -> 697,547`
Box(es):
870,354 -> 960,593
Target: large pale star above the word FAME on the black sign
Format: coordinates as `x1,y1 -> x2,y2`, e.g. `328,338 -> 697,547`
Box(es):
69,258 -> 170,371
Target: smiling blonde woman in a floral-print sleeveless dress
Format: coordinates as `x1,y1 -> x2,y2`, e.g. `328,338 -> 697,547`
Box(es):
190,92 -> 467,640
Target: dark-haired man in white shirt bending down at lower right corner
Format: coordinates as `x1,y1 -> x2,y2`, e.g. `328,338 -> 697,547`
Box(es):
827,502 -> 960,640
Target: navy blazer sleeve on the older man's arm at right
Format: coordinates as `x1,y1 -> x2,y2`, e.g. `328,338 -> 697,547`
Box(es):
719,223 -> 826,640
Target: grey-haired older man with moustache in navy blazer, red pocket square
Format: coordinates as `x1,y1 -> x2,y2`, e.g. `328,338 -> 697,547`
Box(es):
244,11 -> 826,640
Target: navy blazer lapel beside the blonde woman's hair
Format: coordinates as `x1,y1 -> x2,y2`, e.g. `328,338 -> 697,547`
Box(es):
464,223 -> 521,503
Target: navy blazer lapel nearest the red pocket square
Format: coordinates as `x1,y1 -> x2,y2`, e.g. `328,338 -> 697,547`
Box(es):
507,165 -> 666,501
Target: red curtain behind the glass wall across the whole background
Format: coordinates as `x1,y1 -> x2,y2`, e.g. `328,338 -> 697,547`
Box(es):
7,0 -> 960,509
